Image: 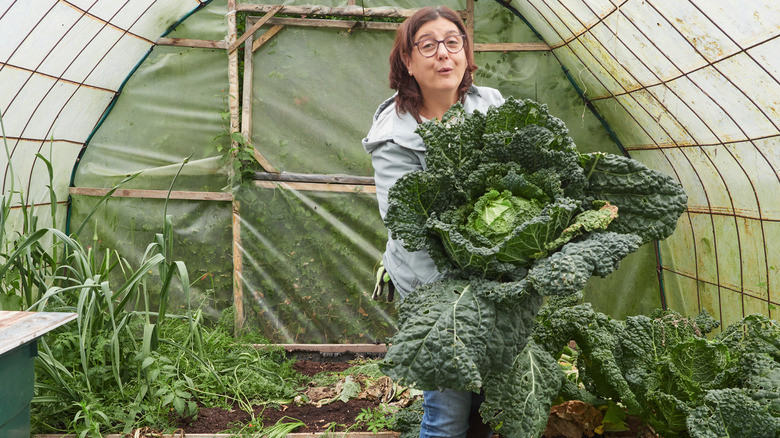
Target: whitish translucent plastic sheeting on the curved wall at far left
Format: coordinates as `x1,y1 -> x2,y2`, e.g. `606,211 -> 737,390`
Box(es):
0,0 -> 200,218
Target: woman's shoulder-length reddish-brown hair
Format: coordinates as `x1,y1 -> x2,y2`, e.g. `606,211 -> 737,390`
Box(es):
390,6 -> 477,122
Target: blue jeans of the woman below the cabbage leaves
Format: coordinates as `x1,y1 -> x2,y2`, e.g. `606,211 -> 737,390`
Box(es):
420,389 -> 493,438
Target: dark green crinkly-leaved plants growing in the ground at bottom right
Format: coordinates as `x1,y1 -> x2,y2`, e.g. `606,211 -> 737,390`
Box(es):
534,295 -> 780,438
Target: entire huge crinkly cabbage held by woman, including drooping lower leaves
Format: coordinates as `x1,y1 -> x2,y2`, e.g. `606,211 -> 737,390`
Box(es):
383,98 -> 687,437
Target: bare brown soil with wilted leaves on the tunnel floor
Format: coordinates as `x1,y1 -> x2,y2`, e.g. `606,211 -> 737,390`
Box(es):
35,345 -> 655,438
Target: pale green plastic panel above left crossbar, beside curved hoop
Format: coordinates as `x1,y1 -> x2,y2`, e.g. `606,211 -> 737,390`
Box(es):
74,46 -> 230,192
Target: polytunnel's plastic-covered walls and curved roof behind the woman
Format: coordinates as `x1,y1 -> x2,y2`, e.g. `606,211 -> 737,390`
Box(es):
0,0 -> 780,343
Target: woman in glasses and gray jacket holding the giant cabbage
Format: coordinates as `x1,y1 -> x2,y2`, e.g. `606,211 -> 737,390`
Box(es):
363,6 -> 504,438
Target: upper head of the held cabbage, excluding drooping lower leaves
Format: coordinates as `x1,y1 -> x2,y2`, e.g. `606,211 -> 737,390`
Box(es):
385,98 -> 687,282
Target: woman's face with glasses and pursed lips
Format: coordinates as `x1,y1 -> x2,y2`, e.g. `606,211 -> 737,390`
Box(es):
406,17 -> 467,103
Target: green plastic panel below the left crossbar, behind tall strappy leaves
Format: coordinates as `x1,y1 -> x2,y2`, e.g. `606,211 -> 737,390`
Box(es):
70,195 -> 233,312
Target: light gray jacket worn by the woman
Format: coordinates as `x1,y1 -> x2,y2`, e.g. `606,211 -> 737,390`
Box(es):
363,86 -> 504,298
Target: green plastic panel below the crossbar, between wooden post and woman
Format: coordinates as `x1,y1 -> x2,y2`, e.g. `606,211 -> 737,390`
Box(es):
232,186 -> 395,343
